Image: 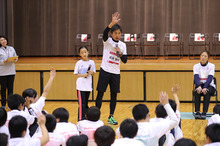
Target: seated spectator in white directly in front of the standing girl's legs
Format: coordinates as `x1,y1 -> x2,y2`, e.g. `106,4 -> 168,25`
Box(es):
77,106 -> 104,145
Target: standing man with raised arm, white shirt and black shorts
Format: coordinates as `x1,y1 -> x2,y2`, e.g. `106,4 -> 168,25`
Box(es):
96,12 -> 127,125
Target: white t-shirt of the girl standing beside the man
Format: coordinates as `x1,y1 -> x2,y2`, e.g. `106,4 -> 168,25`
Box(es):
74,60 -> 96,91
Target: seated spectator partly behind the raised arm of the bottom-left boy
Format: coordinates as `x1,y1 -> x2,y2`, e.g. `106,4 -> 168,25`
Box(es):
34,114 -> 65,146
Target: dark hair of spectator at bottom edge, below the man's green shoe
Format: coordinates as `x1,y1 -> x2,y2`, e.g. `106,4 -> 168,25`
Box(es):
94,126 -> 115,146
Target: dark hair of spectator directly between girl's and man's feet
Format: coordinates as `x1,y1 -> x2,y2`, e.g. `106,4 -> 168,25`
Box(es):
86,106 -> 101,122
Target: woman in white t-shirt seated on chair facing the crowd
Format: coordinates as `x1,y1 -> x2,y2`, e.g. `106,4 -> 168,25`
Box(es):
193,51 -> 216,119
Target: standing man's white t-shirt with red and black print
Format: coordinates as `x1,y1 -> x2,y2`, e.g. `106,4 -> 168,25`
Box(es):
101,37 -> 127,74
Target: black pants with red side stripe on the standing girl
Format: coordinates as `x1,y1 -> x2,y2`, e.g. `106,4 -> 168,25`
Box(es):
77,90 -> 90,121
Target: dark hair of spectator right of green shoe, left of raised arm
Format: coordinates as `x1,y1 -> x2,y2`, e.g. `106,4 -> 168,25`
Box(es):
132,104 -> 149,121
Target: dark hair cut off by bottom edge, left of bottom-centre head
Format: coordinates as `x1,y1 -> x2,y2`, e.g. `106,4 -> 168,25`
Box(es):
66,134 -> 88,146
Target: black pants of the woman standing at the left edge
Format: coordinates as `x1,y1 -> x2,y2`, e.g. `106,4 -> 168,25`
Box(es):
0,75 -> 15,106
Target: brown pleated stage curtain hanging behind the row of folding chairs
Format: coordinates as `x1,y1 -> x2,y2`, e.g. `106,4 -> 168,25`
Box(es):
4,0 -> 220,56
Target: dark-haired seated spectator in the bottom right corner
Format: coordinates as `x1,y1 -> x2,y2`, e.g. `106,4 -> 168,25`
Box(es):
204,124 -> 220,146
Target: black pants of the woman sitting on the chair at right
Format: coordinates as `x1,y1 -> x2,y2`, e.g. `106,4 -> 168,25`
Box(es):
194,86 -> 215,113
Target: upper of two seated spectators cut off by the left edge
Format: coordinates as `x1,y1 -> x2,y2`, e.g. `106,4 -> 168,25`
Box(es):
0,107 -> 10,137
